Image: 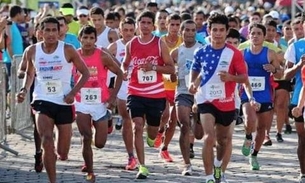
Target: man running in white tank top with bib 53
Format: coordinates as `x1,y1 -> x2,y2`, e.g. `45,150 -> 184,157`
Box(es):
17,17 -> 89,183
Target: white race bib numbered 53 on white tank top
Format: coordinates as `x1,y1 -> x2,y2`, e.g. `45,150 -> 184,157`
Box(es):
42,80 -> 63,96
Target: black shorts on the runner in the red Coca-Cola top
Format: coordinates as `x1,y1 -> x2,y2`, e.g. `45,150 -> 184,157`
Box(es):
127,95 -> 166,126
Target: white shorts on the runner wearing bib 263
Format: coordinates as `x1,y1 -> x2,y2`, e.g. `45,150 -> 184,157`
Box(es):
75,102 -> 108,121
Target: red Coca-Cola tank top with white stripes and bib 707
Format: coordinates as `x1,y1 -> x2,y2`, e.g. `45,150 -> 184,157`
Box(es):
128,36 -> 165,98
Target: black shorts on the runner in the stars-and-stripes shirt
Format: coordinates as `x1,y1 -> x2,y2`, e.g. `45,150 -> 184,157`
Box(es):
198,103 -> 235,126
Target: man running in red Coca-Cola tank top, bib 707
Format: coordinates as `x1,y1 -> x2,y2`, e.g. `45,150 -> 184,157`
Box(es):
122,11 -> 175,179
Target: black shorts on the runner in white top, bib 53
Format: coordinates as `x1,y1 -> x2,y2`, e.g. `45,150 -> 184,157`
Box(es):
31,100 -> 75,125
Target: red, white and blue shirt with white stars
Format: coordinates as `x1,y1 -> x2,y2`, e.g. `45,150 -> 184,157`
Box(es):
192,44 -> 247,111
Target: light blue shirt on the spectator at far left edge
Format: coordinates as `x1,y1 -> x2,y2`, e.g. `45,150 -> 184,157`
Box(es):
3,22 -> 24,63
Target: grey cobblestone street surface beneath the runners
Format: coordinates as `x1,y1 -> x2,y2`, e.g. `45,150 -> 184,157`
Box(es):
0,121 -> 299,183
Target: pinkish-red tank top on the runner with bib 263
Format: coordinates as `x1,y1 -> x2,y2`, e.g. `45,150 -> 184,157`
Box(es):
73,48 -> 109,104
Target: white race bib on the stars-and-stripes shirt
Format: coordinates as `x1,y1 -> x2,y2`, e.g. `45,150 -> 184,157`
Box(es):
206,83 -> 226,100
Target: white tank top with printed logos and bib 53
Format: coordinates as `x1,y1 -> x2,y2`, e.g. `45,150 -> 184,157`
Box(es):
33,41 -> 72,105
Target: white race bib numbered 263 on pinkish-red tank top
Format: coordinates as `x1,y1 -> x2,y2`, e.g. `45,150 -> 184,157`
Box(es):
80,88 -> 102,104
